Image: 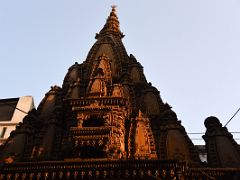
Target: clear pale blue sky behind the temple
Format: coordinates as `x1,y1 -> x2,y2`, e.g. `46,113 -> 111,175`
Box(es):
0,0 -> 240,144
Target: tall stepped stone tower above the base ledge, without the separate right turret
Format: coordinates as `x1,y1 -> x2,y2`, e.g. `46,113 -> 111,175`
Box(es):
1,4 -> 200,166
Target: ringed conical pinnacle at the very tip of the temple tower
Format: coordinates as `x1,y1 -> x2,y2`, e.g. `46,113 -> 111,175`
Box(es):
96,5 -> 124,38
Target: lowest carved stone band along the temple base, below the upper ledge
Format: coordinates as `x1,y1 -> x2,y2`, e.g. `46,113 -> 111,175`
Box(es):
0,169 -> 181,180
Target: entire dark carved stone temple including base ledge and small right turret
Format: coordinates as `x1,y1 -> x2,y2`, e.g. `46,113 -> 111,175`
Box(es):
0,7 -> 240,180
